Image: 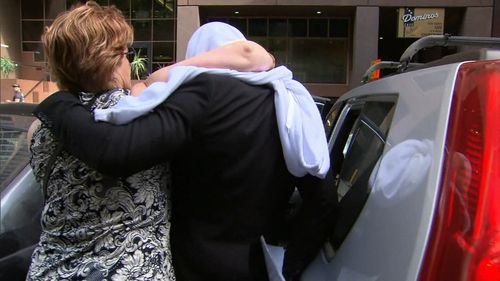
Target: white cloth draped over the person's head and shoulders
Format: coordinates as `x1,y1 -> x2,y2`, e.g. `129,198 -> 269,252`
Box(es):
94,22 -> 330,178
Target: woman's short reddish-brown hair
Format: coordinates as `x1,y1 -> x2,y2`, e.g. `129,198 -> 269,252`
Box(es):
42,1 -> 134,93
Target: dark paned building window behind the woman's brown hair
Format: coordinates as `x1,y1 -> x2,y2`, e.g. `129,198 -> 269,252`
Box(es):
21,0 -> 176,76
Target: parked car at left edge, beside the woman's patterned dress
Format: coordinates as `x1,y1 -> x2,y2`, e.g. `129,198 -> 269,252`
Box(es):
0,103 -> 43,280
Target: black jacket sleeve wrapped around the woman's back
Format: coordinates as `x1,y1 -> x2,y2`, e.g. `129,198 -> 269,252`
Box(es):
34,75 -> 211,176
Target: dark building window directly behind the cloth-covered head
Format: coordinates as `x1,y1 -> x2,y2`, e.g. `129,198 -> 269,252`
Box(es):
208,17 -> 350,84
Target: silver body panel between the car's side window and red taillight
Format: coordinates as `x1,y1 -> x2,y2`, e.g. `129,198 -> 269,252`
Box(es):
302,63 -> 460,281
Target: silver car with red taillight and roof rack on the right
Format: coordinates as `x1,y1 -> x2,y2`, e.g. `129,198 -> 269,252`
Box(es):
302,36 -> 500,281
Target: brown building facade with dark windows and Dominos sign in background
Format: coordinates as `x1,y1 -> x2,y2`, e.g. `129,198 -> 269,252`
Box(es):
0,0 -> 500,102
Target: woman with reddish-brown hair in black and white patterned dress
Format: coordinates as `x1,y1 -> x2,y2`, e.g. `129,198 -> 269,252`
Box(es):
27,2 -> 273,280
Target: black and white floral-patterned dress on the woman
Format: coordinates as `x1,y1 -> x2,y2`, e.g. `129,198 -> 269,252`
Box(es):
27,89 -> 175,281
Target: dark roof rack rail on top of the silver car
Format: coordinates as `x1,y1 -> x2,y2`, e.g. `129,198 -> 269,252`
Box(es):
361,34 -> 500,84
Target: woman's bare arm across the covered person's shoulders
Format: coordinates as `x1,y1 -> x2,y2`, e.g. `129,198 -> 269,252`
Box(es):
132,41 -> 275,96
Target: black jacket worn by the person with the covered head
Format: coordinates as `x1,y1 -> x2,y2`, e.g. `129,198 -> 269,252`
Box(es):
35,74 -> 337,281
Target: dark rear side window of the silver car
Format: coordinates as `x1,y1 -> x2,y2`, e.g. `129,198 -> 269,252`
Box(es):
327,97 -> 396,257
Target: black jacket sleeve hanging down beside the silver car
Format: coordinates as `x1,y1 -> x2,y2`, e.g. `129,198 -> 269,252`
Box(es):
283,171 -> 338,281
